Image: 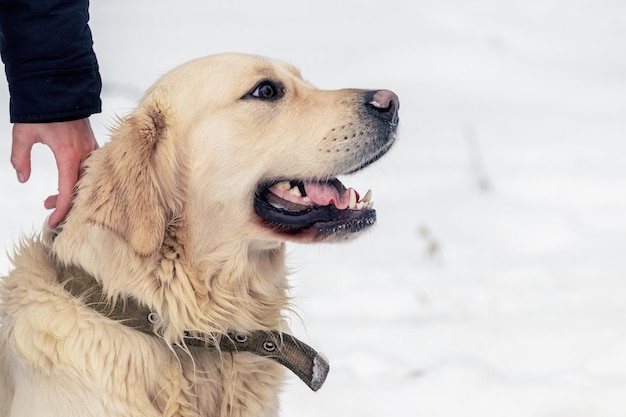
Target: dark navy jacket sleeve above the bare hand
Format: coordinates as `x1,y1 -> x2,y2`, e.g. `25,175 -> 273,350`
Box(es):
0,0 -> 102,123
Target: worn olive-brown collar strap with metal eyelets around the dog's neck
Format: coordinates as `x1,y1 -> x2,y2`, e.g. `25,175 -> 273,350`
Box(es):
57,265 -> 330,391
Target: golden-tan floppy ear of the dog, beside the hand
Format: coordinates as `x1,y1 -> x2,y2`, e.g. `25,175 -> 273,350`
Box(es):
85,105 -> 167,256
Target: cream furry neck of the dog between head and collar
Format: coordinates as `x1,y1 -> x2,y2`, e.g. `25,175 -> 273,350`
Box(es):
52,217 -> 289,344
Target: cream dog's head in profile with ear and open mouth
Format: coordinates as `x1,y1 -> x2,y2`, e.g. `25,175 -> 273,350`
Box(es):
67,54 -> 399,255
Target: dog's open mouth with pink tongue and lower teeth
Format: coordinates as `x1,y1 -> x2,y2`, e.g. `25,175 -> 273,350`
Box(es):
254,178 -> 376,240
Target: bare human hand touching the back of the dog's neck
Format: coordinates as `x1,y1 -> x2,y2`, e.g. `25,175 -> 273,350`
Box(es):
11,119 -> 98,228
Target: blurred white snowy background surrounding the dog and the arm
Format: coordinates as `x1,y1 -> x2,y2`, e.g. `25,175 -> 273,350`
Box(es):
0,0 -> 626,417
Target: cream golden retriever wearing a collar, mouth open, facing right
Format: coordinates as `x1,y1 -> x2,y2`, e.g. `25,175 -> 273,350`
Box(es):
0,54 -> 399,417
